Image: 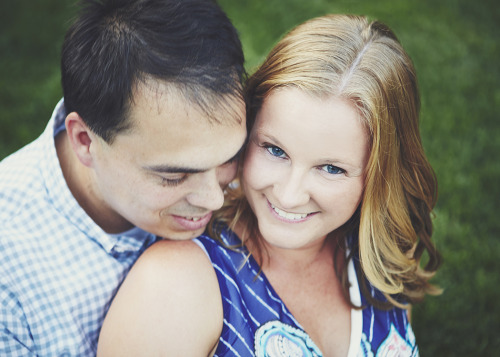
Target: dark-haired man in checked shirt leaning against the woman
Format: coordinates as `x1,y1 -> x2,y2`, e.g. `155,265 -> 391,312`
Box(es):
0,0 -> 246,356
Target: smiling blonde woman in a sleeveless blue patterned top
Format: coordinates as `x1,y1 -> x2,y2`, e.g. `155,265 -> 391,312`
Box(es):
99,15 -> 439,356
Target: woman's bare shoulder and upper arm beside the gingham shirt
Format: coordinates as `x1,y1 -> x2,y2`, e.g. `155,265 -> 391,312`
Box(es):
97,241 -> 223,356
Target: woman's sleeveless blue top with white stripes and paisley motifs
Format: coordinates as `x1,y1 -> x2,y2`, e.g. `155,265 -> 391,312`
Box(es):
195,224 -> 418,357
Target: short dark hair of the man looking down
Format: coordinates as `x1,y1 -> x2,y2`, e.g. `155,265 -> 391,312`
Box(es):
61,0 -> 245,142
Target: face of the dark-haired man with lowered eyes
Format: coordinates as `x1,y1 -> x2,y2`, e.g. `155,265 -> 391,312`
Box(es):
90,86 -> 246,239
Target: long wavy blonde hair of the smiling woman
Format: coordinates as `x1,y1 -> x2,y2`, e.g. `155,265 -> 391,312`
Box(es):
213,15 -> 440,306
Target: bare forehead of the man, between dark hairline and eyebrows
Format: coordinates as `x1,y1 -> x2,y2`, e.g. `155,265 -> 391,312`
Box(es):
116,78 -> 246,173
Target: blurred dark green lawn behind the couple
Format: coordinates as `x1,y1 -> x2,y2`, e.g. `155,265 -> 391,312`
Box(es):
0,0 -> 500,356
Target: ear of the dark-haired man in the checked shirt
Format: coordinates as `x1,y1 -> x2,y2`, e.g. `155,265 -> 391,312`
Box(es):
65,112 -> 96,167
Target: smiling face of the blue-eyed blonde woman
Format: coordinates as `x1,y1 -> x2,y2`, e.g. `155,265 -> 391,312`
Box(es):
243,88 -> 369,249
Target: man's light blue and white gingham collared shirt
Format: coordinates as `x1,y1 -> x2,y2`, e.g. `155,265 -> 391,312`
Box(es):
0,101 -> 154,356
